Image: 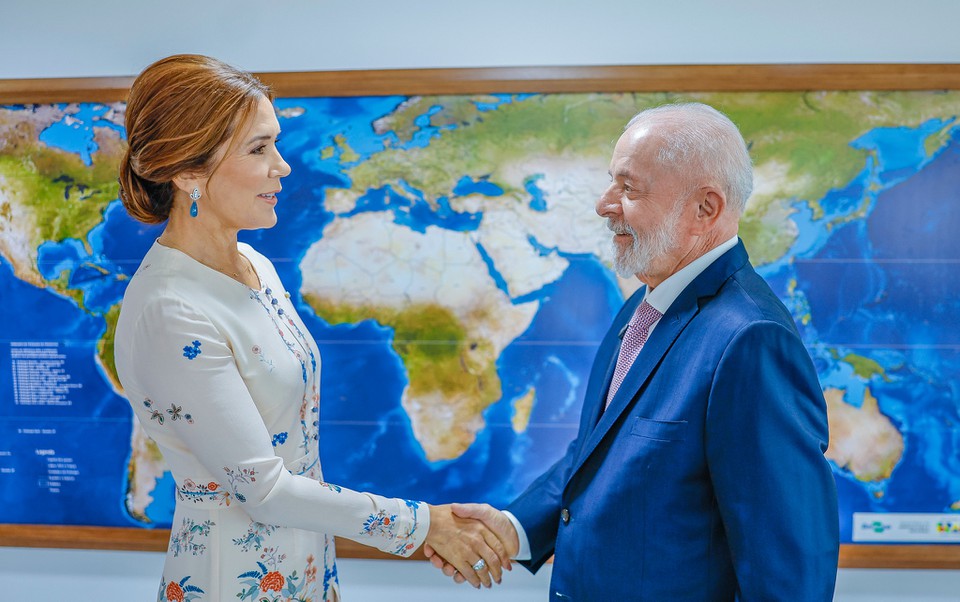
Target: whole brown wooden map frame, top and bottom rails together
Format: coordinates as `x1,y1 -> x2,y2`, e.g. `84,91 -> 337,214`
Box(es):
0,64 -> 960,569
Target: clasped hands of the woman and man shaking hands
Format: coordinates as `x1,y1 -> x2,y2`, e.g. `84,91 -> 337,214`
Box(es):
423,504 -> 520,588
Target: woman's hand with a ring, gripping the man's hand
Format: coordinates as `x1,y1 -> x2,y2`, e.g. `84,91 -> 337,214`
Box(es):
424,505 -> 510,587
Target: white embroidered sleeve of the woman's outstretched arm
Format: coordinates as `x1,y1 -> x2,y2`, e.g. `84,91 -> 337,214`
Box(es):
123,296 -> 429,556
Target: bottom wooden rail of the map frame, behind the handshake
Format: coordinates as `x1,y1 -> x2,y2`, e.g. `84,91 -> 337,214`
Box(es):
0,525 -> 960,570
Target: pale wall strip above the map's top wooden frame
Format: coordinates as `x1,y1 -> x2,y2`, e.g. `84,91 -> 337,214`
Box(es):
0,0 -> 960,78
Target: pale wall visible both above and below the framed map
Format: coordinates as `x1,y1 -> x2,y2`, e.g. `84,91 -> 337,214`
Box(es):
0,0 -> 960,602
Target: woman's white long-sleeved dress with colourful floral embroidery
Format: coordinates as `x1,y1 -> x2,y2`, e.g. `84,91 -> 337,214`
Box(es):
115,243 -> 429,602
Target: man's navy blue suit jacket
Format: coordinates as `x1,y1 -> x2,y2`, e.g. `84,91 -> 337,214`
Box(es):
507,242 -> 839,602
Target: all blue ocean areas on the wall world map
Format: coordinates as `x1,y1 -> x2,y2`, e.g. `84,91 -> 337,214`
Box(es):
0,96 -> 960,542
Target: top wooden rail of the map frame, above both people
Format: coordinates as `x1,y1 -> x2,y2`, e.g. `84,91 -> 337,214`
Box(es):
0,63 -> 960,104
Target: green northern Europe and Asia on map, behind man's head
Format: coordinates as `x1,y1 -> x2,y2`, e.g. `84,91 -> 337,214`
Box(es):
334,91 -> 960,265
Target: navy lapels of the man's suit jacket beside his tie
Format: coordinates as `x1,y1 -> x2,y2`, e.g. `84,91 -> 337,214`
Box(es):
571,241 -> 749,475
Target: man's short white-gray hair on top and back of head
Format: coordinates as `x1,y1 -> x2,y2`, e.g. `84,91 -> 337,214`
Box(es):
624,102 -> 753,214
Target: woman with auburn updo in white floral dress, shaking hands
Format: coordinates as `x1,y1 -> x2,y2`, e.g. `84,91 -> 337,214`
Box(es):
116,55 -> 509,602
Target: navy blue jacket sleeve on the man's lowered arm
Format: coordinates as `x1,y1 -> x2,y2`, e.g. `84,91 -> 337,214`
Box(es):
706,322 -> 838,601
